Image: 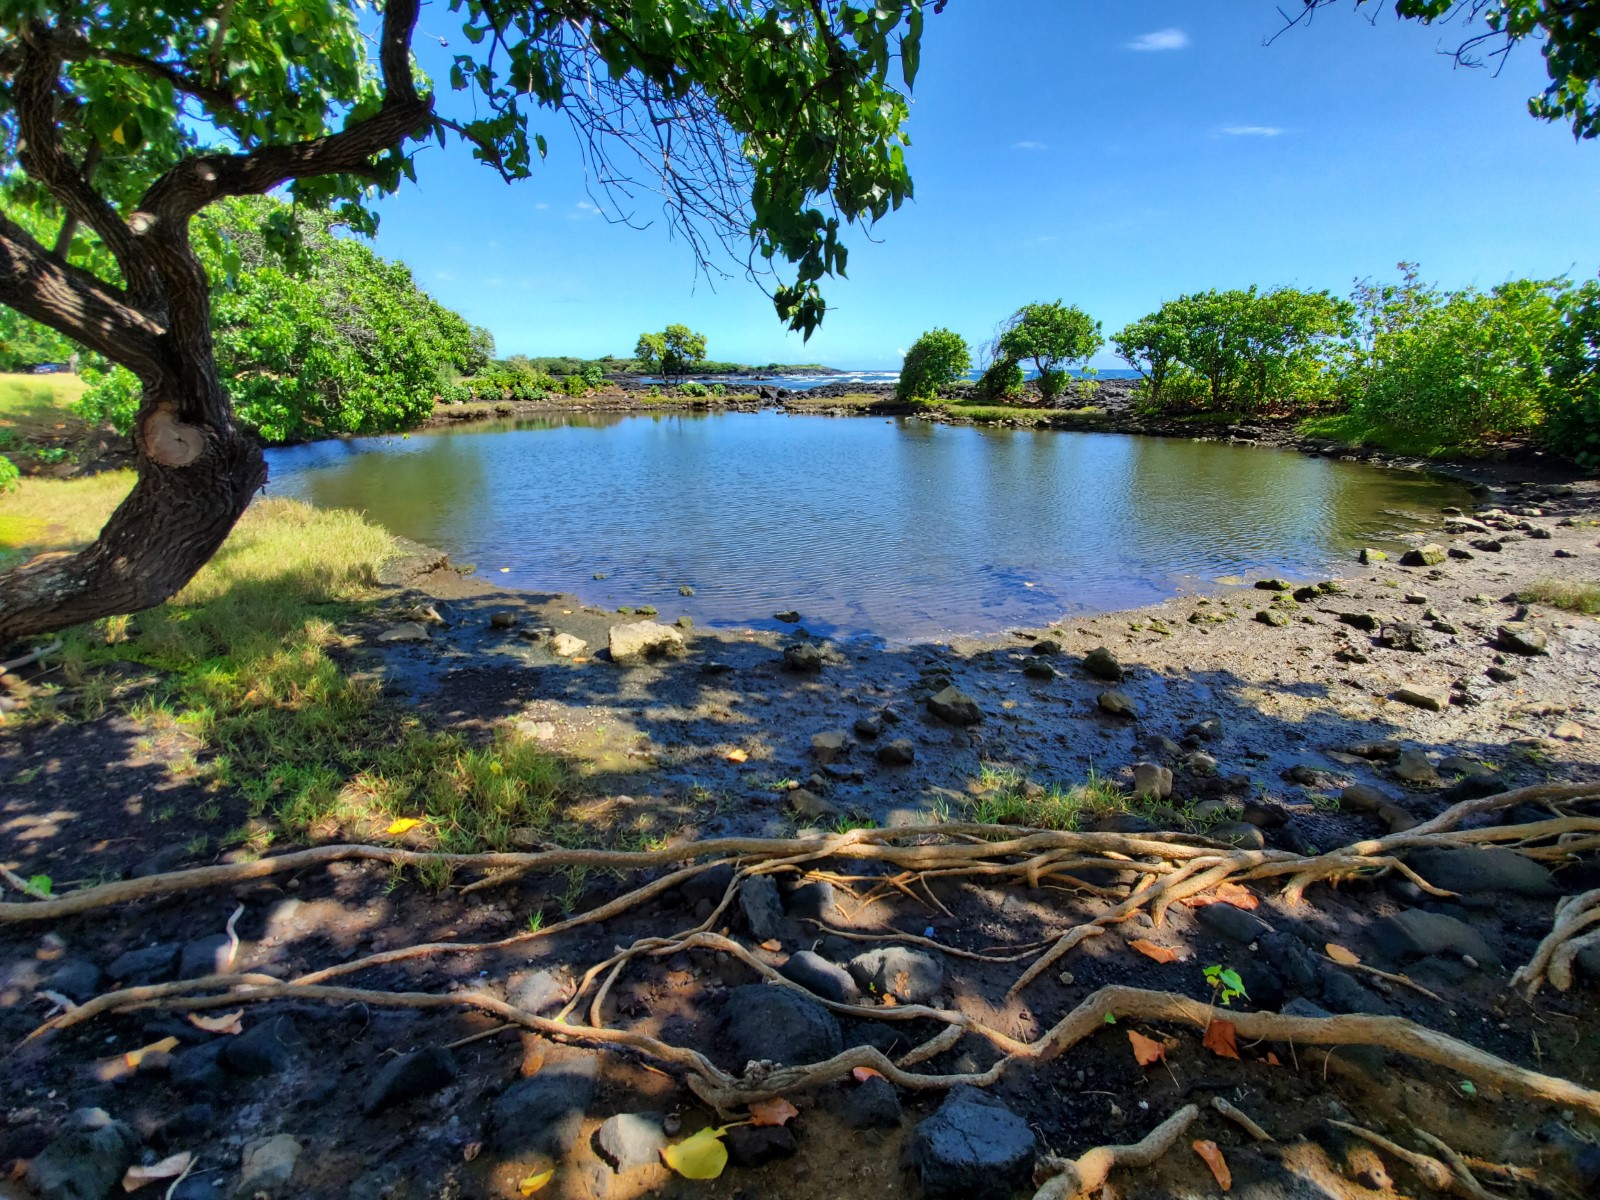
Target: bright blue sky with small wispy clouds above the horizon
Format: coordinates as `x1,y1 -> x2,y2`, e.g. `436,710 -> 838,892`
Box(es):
368,0 -> 1600,368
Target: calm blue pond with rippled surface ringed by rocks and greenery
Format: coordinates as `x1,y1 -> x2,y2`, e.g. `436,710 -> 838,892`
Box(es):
267,413 -> 1469,640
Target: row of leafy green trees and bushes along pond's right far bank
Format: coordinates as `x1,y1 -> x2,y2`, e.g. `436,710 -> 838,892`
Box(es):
899,270 -> 1600,466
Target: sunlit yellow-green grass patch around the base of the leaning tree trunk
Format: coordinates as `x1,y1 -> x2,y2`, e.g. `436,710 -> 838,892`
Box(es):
0,472 -> 568,876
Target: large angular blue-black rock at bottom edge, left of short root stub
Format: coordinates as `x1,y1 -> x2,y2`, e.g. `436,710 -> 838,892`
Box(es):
910,1085 -> 1037,1200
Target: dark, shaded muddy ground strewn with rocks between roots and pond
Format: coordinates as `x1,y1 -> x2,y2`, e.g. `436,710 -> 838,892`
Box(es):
0,454 -> 1600,1200
